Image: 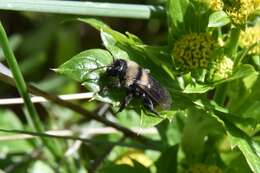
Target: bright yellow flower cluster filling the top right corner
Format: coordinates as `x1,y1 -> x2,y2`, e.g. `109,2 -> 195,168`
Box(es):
226,0 -> 259,25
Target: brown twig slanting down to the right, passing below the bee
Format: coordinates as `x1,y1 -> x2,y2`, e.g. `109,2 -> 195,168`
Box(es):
0,73 -> 163,149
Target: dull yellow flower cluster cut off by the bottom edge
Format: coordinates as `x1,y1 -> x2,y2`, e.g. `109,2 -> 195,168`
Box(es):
185,164 -> 223,173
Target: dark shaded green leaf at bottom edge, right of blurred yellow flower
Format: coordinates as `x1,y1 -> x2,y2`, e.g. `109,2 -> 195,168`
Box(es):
155,145 -> 179,173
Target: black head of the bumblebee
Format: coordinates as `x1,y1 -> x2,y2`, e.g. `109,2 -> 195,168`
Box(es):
106,59 -> 126,76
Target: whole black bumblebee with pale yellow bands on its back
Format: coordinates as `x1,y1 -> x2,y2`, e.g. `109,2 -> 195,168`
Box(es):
106,59 -> 172,115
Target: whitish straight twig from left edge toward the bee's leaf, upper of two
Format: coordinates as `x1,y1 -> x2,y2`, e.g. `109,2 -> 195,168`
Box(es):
0,92 -> 94,105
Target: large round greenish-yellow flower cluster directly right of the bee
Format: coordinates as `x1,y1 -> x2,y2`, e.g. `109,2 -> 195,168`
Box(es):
172,33 -> 217,70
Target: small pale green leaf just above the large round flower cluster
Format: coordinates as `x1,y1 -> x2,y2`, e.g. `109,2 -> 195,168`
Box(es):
208,11 -> 230,27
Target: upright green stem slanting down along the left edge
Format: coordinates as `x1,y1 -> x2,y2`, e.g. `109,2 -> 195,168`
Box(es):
0,21 -> 61,157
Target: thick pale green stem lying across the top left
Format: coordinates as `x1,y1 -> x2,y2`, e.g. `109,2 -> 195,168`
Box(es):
0,0 -> 164,19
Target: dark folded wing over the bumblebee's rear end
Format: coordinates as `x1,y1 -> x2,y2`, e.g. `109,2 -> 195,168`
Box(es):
137,75 -> 172,109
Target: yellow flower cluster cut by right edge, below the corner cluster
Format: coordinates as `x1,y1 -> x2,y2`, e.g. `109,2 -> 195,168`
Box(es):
239,25 -> 260,54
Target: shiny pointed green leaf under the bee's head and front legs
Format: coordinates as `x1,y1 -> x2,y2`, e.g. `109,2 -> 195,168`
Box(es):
56,49 -> 122,105
